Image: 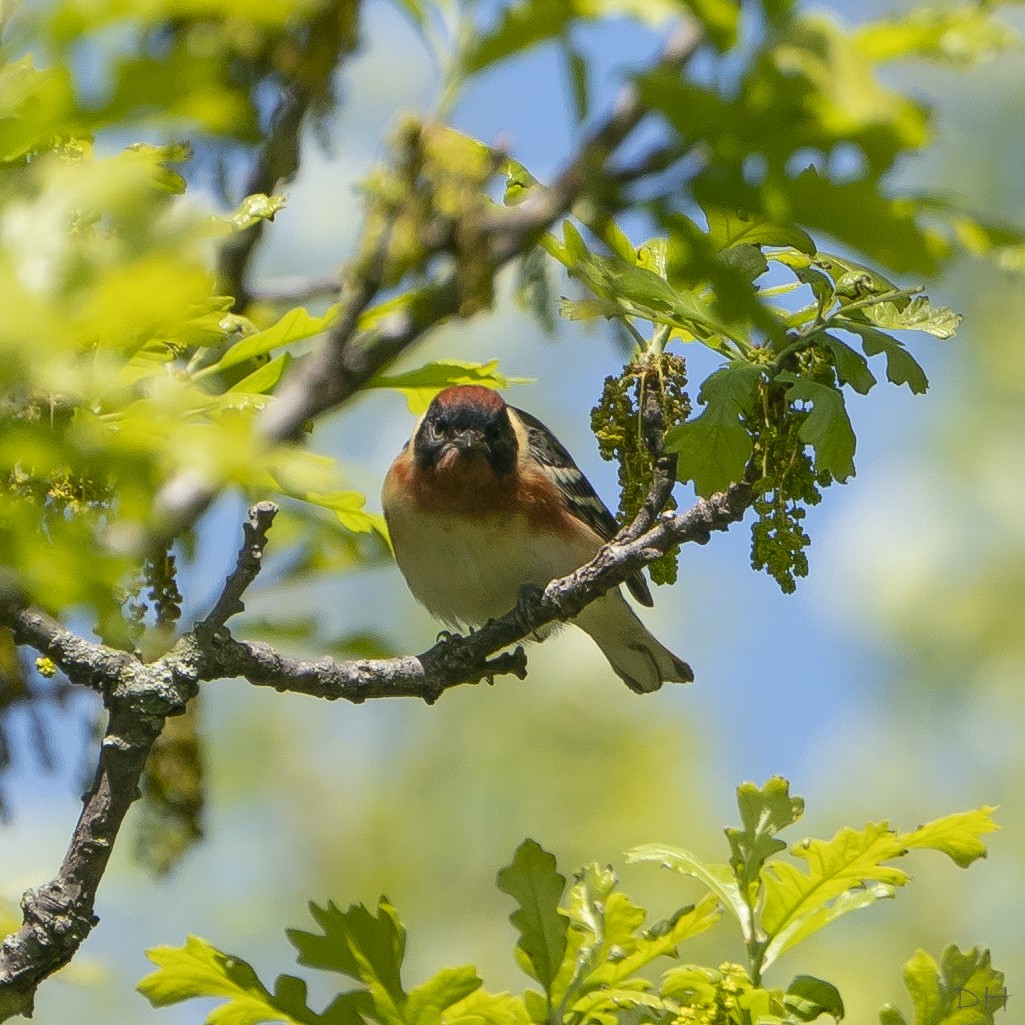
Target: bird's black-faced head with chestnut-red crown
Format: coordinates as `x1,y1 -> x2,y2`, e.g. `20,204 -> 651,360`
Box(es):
413,384 -> 519,477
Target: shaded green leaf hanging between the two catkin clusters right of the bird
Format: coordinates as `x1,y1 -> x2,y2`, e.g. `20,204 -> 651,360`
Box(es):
665,360 -> 762,498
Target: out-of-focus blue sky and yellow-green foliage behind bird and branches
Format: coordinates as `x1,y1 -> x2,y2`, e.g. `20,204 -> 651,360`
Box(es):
0,0 -> 1025,1025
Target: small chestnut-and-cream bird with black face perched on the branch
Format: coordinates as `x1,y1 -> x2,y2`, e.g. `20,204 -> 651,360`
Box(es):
381,384 -> 694,694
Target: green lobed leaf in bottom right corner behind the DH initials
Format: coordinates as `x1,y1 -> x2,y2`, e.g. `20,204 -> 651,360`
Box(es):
902,945 -> 1009,1025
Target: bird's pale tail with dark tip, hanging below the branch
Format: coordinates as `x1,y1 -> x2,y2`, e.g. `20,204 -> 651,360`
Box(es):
573,588 -> 694,694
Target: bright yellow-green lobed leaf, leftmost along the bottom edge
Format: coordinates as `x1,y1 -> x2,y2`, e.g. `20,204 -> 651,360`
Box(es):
137,936 -> 314,1025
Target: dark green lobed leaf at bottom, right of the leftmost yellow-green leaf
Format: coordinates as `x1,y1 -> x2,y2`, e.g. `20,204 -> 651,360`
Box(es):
286,897 -> 406,1025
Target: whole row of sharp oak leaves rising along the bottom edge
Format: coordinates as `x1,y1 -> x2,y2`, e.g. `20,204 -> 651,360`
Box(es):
139,778 -> 1002,1025
